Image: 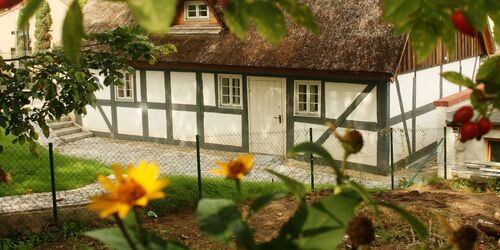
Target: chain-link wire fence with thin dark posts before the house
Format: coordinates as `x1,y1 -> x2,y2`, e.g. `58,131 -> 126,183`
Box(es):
0,127 -> 443,222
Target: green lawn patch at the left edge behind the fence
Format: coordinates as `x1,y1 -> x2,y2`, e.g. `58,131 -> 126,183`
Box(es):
0,134 -> 111,196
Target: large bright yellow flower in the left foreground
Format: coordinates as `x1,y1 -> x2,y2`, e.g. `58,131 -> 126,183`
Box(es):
89,161 -> 168,219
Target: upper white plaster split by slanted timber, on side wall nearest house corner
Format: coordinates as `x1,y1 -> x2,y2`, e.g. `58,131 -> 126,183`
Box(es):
390,72 -> 413,117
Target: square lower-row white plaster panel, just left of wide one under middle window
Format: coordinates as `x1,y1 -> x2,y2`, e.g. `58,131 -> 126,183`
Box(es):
172,110 -> 197,141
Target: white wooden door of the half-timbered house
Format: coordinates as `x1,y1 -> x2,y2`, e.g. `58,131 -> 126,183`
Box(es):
248,77 -> 286,155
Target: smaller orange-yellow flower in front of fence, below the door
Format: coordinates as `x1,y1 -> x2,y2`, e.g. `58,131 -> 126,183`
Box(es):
209,154 -> 253,180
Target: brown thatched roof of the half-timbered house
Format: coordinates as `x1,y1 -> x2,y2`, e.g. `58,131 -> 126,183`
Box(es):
84,0 -> 405,75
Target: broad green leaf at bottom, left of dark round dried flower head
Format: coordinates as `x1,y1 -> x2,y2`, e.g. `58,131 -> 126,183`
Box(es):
297,189 -> 362,249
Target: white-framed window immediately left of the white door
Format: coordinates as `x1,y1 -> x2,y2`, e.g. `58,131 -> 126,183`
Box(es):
219,75 -> 242,108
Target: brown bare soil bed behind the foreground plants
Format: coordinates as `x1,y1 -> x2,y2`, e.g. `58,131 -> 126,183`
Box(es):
36,186 -> 500,249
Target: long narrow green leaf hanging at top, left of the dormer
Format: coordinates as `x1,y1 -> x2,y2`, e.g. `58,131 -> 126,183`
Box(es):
62,1 -> 83,63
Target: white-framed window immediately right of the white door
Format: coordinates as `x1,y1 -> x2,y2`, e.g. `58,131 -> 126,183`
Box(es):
295,81 -> 321,116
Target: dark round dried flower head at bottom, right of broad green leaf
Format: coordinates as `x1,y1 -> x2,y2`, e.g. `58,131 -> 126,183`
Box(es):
347,216 -> 375,246
